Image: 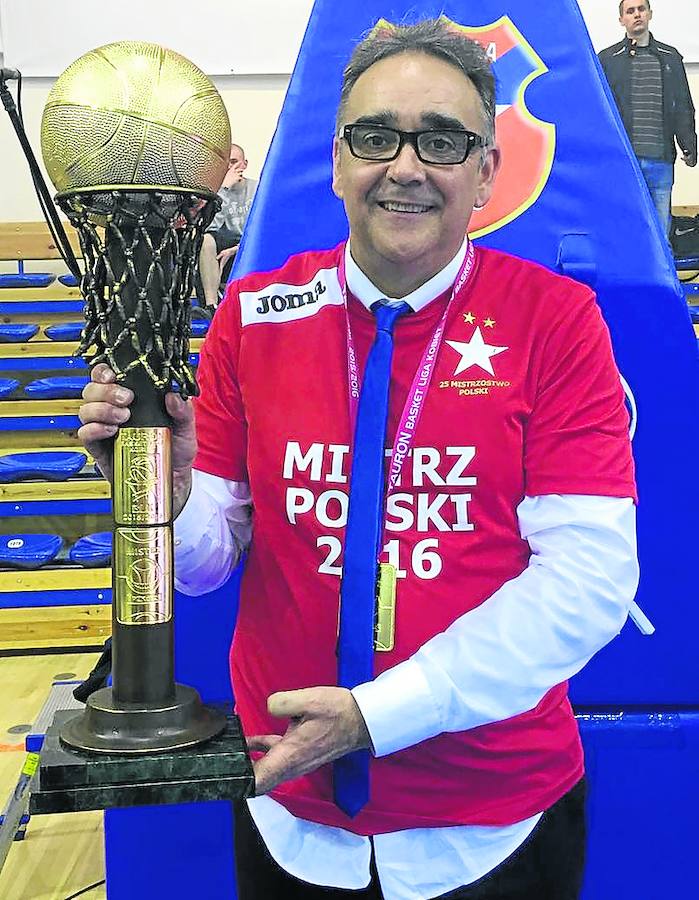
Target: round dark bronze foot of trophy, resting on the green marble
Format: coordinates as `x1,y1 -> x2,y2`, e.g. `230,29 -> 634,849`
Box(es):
60,684 -> 226,754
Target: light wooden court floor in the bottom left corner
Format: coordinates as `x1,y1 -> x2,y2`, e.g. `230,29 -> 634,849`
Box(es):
0,653 -> 107,900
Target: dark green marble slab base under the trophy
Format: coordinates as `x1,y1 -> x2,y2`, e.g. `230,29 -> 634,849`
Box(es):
29,709 -> 255,814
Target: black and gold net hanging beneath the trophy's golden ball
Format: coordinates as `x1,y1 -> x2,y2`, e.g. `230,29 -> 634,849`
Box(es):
56,189 -> 220,400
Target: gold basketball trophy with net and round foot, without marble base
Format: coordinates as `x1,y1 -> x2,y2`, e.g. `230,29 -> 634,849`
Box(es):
41,41 -> 231,754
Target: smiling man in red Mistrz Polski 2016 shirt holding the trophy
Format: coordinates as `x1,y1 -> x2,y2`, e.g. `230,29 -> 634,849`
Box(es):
80,21 -> 638,900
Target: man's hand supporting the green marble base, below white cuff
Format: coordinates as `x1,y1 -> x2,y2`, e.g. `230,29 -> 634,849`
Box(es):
248,687 -> 371,796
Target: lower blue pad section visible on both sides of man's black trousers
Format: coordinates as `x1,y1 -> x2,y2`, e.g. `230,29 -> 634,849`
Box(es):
105,712 -> 699,900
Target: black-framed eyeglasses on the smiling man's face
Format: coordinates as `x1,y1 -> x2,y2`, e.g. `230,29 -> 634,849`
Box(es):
342,122 -> 485,166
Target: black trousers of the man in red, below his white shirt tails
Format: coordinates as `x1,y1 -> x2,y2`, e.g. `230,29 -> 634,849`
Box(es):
235,779 -> 586,900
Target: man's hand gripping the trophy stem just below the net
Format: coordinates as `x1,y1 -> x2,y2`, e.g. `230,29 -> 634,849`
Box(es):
78,363 -> 197,518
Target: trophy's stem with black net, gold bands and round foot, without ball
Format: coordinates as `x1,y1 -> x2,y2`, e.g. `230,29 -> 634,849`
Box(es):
59,213 -> 225,754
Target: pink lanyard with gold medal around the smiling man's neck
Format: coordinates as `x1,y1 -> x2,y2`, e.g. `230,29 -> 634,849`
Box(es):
338,241 -> 475,652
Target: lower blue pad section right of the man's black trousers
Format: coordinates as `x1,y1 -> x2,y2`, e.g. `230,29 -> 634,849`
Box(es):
578,710 -> 699,900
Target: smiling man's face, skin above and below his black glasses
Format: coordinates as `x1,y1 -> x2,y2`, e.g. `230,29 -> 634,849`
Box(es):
333,53 -> 499,288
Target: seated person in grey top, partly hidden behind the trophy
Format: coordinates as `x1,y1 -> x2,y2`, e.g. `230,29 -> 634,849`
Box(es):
199,144 -> 257,307
